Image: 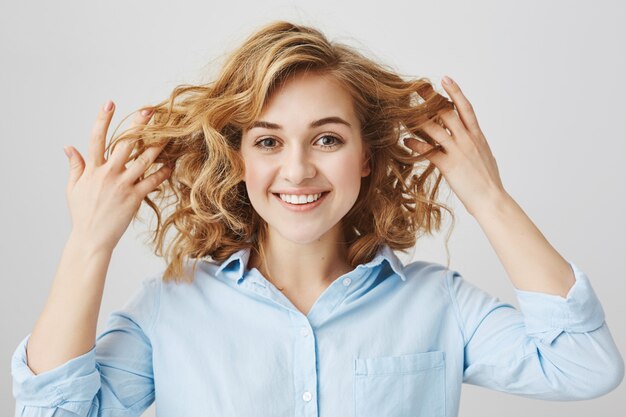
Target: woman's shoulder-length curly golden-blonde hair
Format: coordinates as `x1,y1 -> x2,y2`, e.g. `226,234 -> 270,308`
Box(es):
107,21 -> 454,282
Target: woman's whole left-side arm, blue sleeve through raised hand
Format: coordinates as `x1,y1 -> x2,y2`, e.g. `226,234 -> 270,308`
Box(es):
12,102 -> 170,416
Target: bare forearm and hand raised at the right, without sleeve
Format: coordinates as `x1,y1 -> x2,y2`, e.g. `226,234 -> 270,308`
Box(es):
405,77 -> 574,297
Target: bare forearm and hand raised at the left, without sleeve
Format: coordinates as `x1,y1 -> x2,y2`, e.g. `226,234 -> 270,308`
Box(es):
28,101 -> 169,373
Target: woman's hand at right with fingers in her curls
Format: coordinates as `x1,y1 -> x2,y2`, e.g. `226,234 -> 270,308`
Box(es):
404,77 -> 506,216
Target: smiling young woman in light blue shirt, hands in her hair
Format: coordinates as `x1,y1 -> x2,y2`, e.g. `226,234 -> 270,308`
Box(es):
12,22 -> 624,417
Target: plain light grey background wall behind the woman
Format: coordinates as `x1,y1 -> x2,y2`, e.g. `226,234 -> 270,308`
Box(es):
0,0 -> 626,417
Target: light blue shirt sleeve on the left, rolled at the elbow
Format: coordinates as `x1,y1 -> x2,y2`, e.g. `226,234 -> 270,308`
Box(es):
11,277 -> 160,417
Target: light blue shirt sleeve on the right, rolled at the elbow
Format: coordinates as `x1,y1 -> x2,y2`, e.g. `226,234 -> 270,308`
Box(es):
448,261 -> 624,400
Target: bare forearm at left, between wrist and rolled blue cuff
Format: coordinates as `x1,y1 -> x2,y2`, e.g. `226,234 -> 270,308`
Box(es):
27,235 -> 111,374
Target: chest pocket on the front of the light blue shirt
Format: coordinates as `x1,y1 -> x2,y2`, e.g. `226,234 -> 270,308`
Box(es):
354,351 -> 445,417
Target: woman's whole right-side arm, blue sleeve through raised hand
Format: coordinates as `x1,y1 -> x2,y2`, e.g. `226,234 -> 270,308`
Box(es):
405,78 -> 624,400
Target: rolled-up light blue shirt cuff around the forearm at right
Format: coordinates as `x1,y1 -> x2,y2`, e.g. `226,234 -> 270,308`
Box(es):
515,261 -> 604,344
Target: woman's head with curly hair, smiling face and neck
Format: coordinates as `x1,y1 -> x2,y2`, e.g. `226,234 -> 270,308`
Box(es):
95,22 -> 453,288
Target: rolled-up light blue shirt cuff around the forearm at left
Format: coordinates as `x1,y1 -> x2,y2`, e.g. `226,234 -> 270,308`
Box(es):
11,334 -> 100,407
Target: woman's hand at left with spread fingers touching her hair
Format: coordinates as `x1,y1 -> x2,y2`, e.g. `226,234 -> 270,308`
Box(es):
66,101 -> 171,252
